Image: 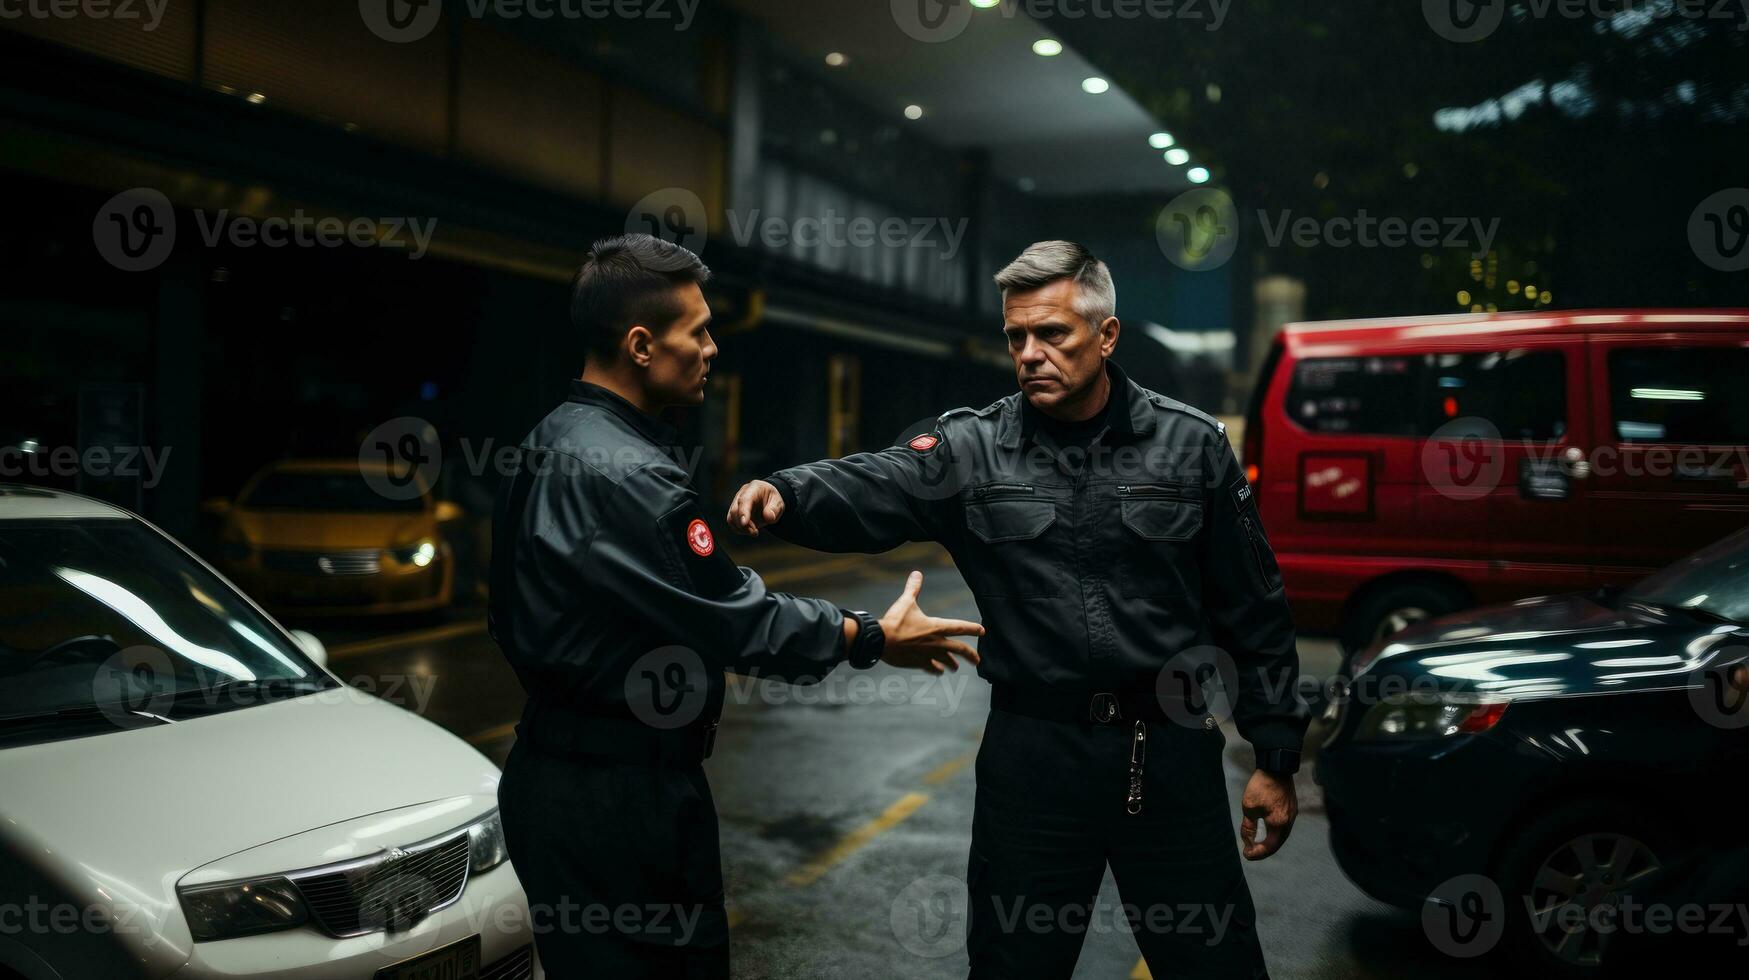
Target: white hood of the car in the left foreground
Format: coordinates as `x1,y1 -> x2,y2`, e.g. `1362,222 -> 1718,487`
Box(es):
0,688 -> 498,973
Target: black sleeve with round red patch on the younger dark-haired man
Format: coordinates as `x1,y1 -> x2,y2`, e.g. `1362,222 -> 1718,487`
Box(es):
539,466 -> 845,683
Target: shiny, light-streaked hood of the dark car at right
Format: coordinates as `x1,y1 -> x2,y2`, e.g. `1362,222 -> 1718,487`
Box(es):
1352,593 -> 1749,700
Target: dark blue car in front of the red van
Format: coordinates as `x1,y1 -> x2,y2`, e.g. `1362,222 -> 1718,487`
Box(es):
1317,529 -> 1749,977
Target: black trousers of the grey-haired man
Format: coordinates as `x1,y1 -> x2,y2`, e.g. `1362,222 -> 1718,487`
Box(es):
967,709 -> 1268,980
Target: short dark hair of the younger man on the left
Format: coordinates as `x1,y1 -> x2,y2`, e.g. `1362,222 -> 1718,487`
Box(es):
570,235 -> 710,361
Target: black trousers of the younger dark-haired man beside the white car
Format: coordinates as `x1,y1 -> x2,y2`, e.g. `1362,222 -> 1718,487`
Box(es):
498,739 -> 729,980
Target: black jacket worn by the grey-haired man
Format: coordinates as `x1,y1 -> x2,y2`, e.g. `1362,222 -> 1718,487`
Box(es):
766,362 -> 1308,772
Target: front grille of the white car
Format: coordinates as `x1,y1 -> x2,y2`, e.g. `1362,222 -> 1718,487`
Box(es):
289,830 -> 469,938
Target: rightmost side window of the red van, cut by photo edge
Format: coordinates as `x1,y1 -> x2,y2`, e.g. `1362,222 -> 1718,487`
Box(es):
1609,347 -> 1749,446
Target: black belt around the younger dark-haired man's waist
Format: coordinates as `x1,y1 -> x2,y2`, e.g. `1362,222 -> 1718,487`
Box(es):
516,700 -> 717,768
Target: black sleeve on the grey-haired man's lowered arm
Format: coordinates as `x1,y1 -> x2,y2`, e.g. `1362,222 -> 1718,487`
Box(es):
1198,436 -> 1310,760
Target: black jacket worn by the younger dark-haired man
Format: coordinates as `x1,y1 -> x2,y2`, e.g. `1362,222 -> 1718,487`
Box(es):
490,382 -> 845,721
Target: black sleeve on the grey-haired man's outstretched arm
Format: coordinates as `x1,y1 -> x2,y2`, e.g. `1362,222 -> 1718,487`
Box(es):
766,427 -> 953,553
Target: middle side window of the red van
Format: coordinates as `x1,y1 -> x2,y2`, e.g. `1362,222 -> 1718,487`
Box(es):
1422,350 -> 1567,441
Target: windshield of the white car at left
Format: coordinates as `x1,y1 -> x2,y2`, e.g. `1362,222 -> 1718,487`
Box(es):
0,520 -> 334,746
